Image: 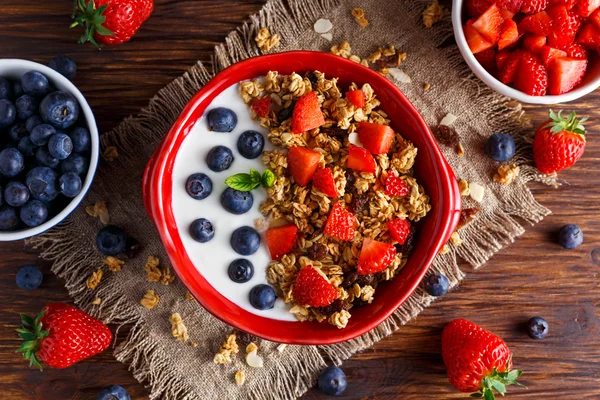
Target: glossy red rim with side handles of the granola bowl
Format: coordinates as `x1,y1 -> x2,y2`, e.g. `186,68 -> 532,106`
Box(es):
142,51 -> 461,345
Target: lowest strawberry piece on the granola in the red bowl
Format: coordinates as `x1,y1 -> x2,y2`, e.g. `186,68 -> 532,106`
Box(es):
292,265 -> 339,307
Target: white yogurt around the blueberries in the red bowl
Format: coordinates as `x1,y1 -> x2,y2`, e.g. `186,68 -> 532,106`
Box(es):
172,84 -> 296,321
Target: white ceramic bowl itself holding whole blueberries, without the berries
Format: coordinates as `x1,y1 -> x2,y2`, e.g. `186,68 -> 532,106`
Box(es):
0,58 -> 100,242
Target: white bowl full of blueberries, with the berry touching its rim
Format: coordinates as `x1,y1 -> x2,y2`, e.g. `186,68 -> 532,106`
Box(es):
0,57 -> 99,241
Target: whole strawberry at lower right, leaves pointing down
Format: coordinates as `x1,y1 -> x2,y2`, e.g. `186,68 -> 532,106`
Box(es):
442,319 -> 523,400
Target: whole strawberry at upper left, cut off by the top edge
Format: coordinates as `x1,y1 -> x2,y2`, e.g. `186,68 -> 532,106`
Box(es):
71,0 -> 154,47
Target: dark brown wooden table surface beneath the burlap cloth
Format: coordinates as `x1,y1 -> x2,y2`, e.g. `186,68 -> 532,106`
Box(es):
0,0 -> 600,400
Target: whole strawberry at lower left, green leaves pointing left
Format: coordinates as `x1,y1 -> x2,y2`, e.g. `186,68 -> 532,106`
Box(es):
17,303 -> 112,370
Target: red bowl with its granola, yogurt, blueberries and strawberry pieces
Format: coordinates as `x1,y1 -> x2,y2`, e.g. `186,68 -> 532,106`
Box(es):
143,51 -> 461,344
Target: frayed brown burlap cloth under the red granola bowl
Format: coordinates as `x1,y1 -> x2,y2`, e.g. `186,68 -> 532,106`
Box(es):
30,0 -> 549,399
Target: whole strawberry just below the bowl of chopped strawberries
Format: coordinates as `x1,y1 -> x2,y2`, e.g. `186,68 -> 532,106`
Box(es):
533,110 -> 587,174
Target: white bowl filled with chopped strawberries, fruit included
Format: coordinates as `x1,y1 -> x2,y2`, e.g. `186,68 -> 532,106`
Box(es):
452,0 -> 600,104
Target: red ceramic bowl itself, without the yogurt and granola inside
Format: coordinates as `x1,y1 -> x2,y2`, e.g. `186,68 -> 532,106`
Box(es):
143,51 -> 461,345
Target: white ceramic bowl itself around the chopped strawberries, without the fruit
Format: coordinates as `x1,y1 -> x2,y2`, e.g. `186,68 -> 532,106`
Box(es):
452,0 -> 600,104
